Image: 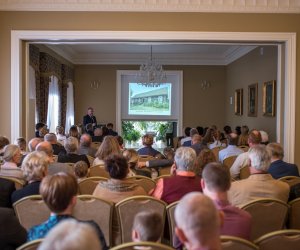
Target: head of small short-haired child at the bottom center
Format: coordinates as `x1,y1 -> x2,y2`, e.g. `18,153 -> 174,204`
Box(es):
132,211 -> 163,242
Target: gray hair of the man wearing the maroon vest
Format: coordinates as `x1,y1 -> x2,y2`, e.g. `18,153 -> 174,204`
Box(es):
174,147 -> 196,171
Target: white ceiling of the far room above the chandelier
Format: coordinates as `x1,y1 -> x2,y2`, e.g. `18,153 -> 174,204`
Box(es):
46,42 -> 257,65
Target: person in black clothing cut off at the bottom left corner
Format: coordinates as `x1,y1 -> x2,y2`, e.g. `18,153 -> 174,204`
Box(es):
0,207 -> 27,250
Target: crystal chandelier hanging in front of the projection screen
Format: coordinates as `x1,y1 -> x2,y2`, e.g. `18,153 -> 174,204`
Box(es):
136,45 -> 167,87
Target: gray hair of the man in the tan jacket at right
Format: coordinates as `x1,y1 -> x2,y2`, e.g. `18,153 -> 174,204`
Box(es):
248,145 -> 271,172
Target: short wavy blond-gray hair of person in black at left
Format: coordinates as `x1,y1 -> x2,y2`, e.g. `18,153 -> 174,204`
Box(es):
21,151 -> 49,181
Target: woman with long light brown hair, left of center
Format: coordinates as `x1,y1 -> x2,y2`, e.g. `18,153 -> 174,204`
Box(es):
93,135 -> 121,167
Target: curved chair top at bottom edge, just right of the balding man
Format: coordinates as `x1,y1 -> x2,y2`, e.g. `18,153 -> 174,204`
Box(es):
221,235 -> 258,250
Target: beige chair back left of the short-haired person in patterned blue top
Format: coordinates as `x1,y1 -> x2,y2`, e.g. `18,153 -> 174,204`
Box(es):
13,195 -> 50,231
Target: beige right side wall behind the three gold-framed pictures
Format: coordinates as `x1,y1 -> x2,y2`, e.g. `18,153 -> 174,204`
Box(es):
225,46 -> 277,141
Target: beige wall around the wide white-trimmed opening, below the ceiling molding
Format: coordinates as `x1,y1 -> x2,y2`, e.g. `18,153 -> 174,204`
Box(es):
0,12 -> 300,164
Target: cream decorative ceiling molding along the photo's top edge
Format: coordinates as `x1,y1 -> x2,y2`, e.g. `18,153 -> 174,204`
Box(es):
0,0 -> 300,13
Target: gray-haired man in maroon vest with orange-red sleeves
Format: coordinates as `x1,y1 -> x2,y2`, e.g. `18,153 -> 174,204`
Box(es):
150,147 -> 202,204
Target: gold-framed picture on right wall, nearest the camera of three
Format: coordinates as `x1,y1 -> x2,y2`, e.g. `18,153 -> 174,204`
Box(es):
263,80 -> 276,116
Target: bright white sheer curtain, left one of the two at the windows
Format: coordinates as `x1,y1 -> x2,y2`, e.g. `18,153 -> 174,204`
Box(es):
47,76 -> 59,133
